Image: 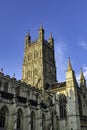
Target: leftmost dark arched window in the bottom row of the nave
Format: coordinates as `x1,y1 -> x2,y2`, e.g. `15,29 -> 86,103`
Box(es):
0,107 -> 8,128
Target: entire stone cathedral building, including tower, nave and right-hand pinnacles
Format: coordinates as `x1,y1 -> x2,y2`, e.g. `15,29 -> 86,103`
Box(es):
0,27 -> 87,130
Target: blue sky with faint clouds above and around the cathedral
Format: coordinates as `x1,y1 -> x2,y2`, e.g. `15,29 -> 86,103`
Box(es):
0,0 -> 87,81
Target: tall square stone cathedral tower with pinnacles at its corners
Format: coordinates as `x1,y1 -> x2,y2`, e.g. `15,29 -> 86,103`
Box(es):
22,26 -> 56,89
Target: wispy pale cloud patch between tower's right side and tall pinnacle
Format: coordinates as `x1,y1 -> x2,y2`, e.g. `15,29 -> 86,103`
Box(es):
55,42 -> 67,82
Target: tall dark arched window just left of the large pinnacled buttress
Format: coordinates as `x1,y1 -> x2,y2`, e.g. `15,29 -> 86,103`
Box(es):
59,94 -> 66,118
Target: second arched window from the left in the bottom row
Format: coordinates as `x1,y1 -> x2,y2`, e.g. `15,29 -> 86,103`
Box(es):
17,109 -> 23,130
